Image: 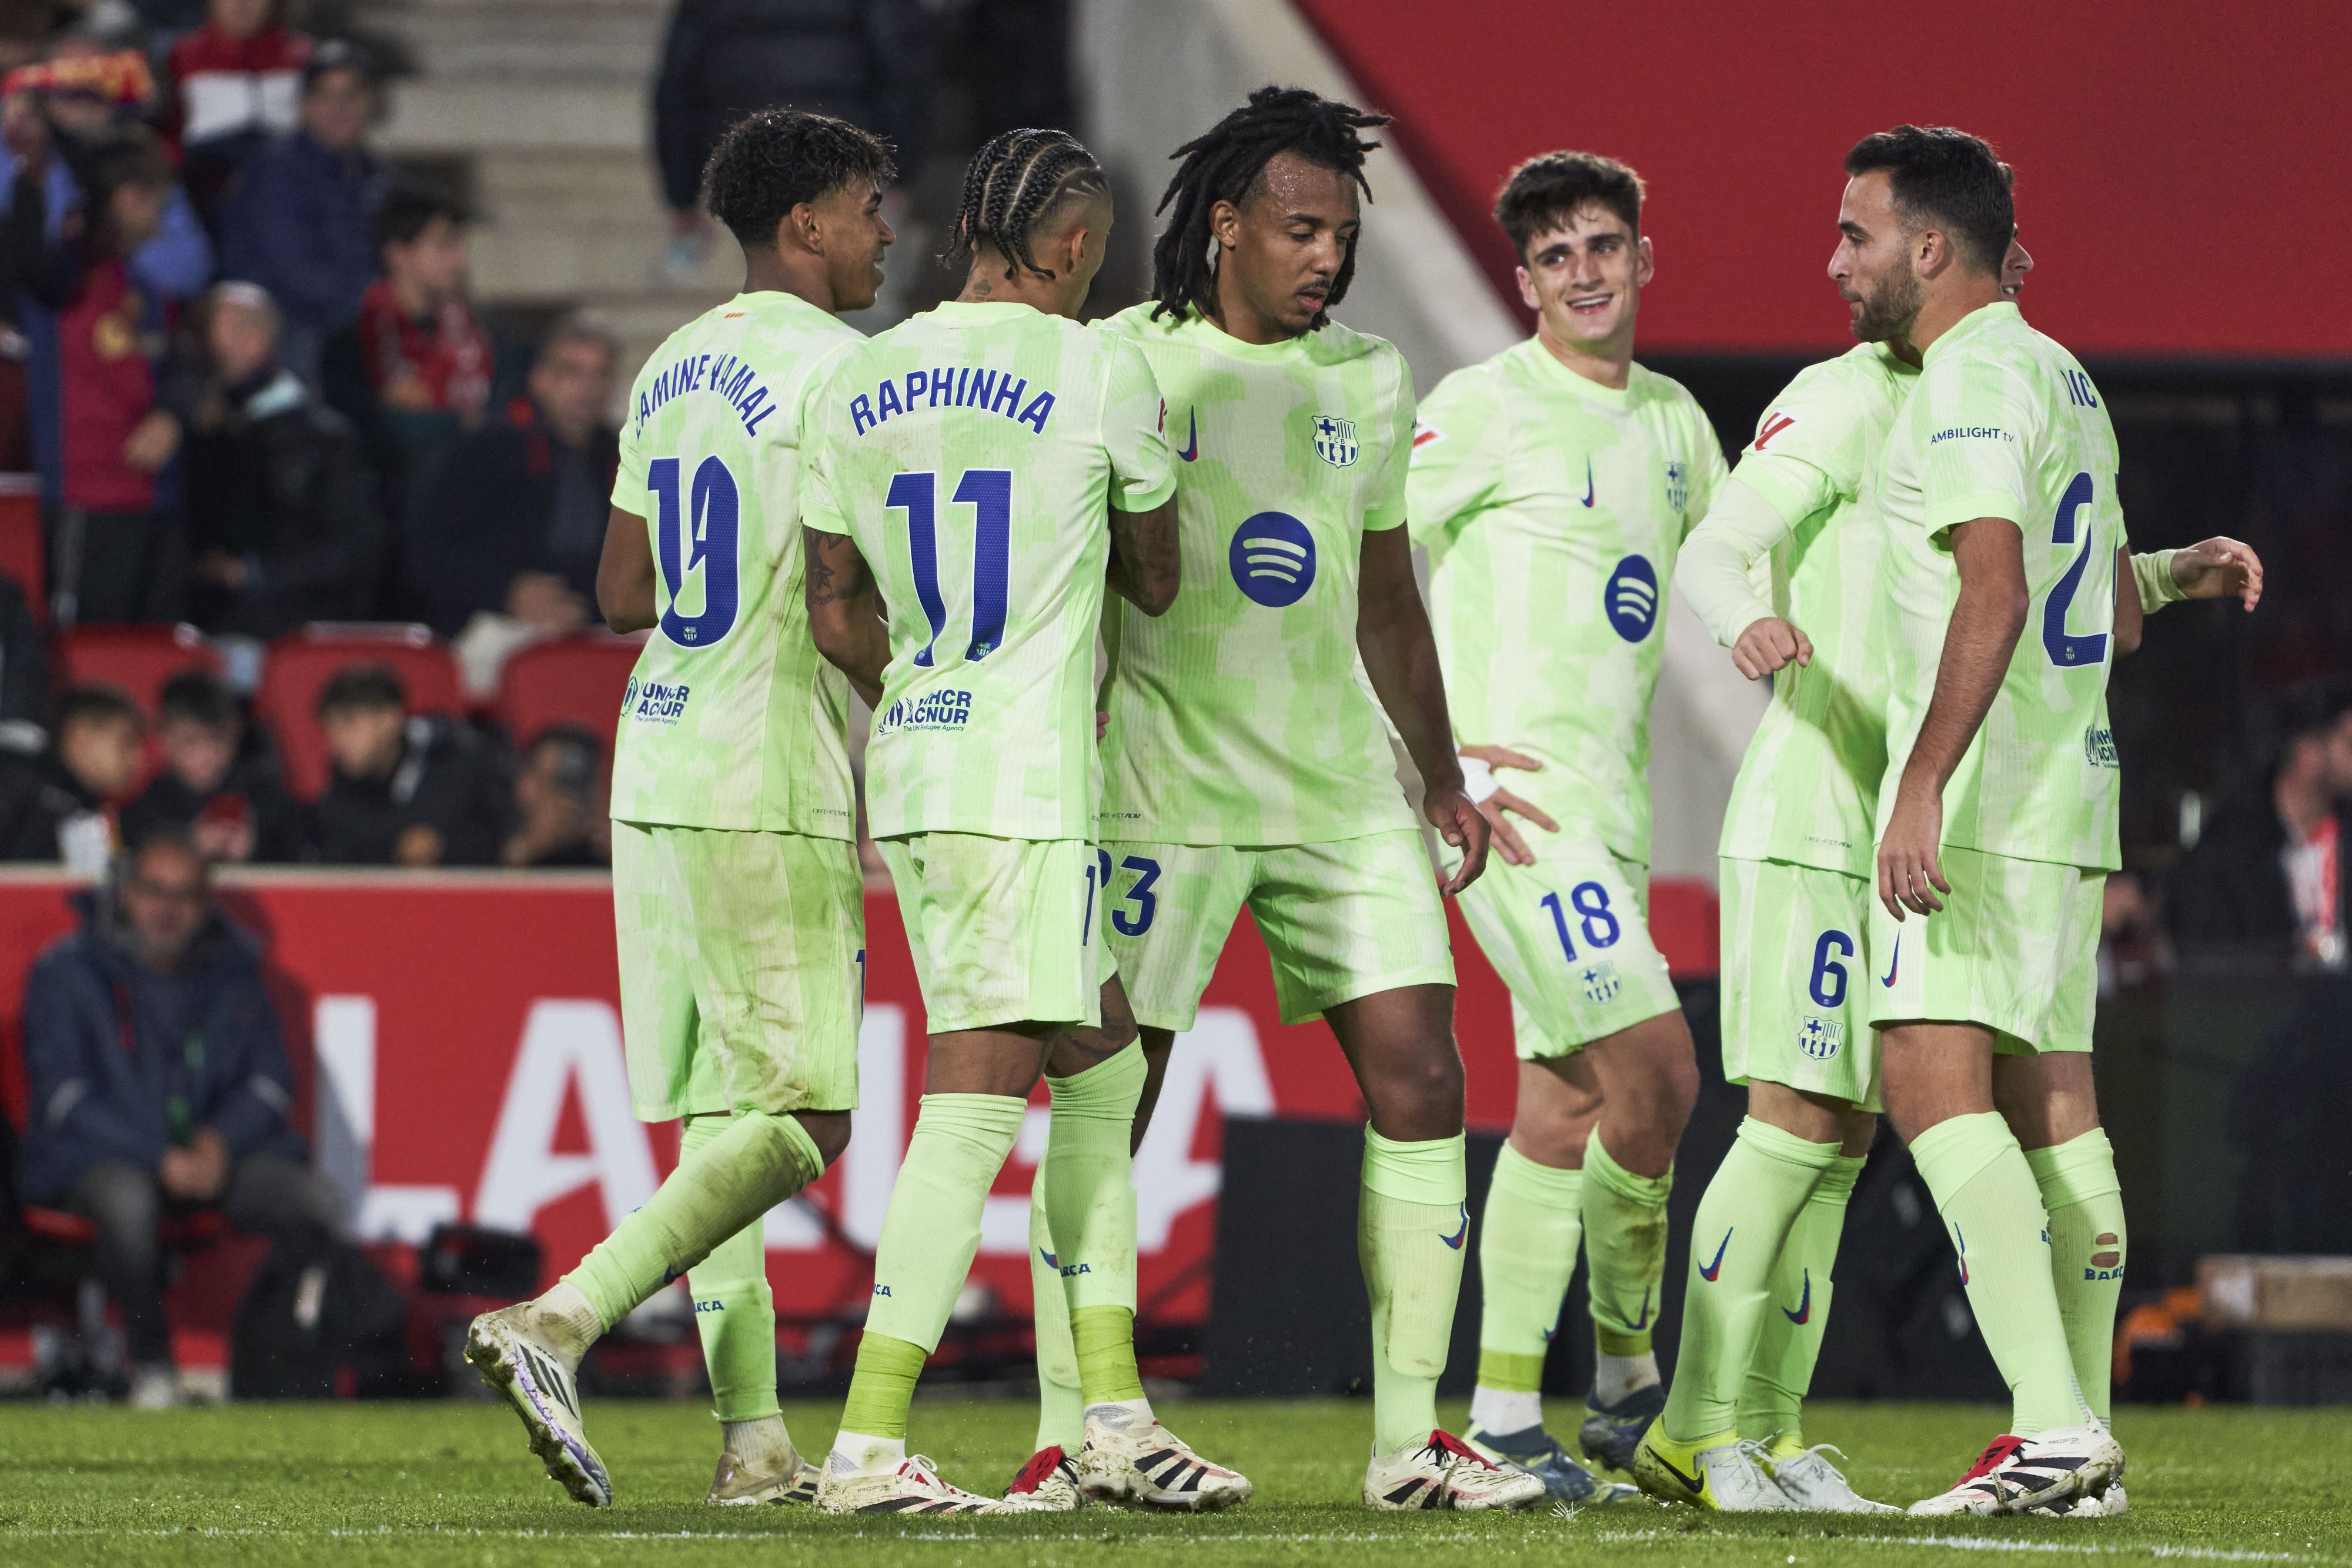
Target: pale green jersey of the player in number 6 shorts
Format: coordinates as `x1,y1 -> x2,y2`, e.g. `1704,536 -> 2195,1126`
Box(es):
1705,343 -> 1919,877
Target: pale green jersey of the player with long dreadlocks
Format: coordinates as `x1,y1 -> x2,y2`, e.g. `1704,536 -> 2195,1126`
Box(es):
1103,306 -> 1414,846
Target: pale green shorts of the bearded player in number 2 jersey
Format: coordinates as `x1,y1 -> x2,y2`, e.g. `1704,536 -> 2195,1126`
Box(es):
1870,844 -> 2107,1055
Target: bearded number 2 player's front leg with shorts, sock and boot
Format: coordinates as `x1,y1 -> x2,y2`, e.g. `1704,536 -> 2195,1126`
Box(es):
1870,846 -> 2122,1514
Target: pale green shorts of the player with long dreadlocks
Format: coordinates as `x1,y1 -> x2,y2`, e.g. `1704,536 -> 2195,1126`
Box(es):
1103,827 -> 1454,1029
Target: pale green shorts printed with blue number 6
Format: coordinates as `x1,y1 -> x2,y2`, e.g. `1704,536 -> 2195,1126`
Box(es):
1719,855 -> 1882,1109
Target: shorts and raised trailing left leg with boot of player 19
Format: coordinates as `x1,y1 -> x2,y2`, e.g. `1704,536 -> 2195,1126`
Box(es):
466,825 -> 866,1505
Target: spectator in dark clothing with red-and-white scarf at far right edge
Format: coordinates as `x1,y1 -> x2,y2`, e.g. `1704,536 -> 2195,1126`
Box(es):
2171,680 -> 2352,971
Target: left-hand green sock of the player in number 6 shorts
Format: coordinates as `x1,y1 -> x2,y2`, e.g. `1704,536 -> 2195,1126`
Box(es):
1665,1116 -> 1837,1443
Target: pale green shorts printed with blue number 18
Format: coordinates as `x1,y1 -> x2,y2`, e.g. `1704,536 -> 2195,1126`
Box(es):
1461,825 -> 1682,1062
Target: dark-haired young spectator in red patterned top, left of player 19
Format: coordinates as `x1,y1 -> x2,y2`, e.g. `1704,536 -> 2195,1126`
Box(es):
320,190 -> 499,554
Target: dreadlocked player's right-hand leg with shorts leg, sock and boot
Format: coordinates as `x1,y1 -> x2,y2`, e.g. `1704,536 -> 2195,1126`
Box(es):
1249,832 -> 1543,1509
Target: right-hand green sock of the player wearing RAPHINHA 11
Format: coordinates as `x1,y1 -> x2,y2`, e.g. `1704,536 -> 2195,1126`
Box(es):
1037,1046 -> 1145,1406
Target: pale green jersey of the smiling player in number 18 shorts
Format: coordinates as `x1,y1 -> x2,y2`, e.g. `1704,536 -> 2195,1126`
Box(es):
1411,339 -> 1726,865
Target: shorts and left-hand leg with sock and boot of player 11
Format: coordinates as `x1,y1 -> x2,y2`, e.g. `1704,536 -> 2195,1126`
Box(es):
816,832 -> 1127,1514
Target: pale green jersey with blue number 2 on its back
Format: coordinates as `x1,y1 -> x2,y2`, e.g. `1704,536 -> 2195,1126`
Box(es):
1879,301 -> 2124,870
